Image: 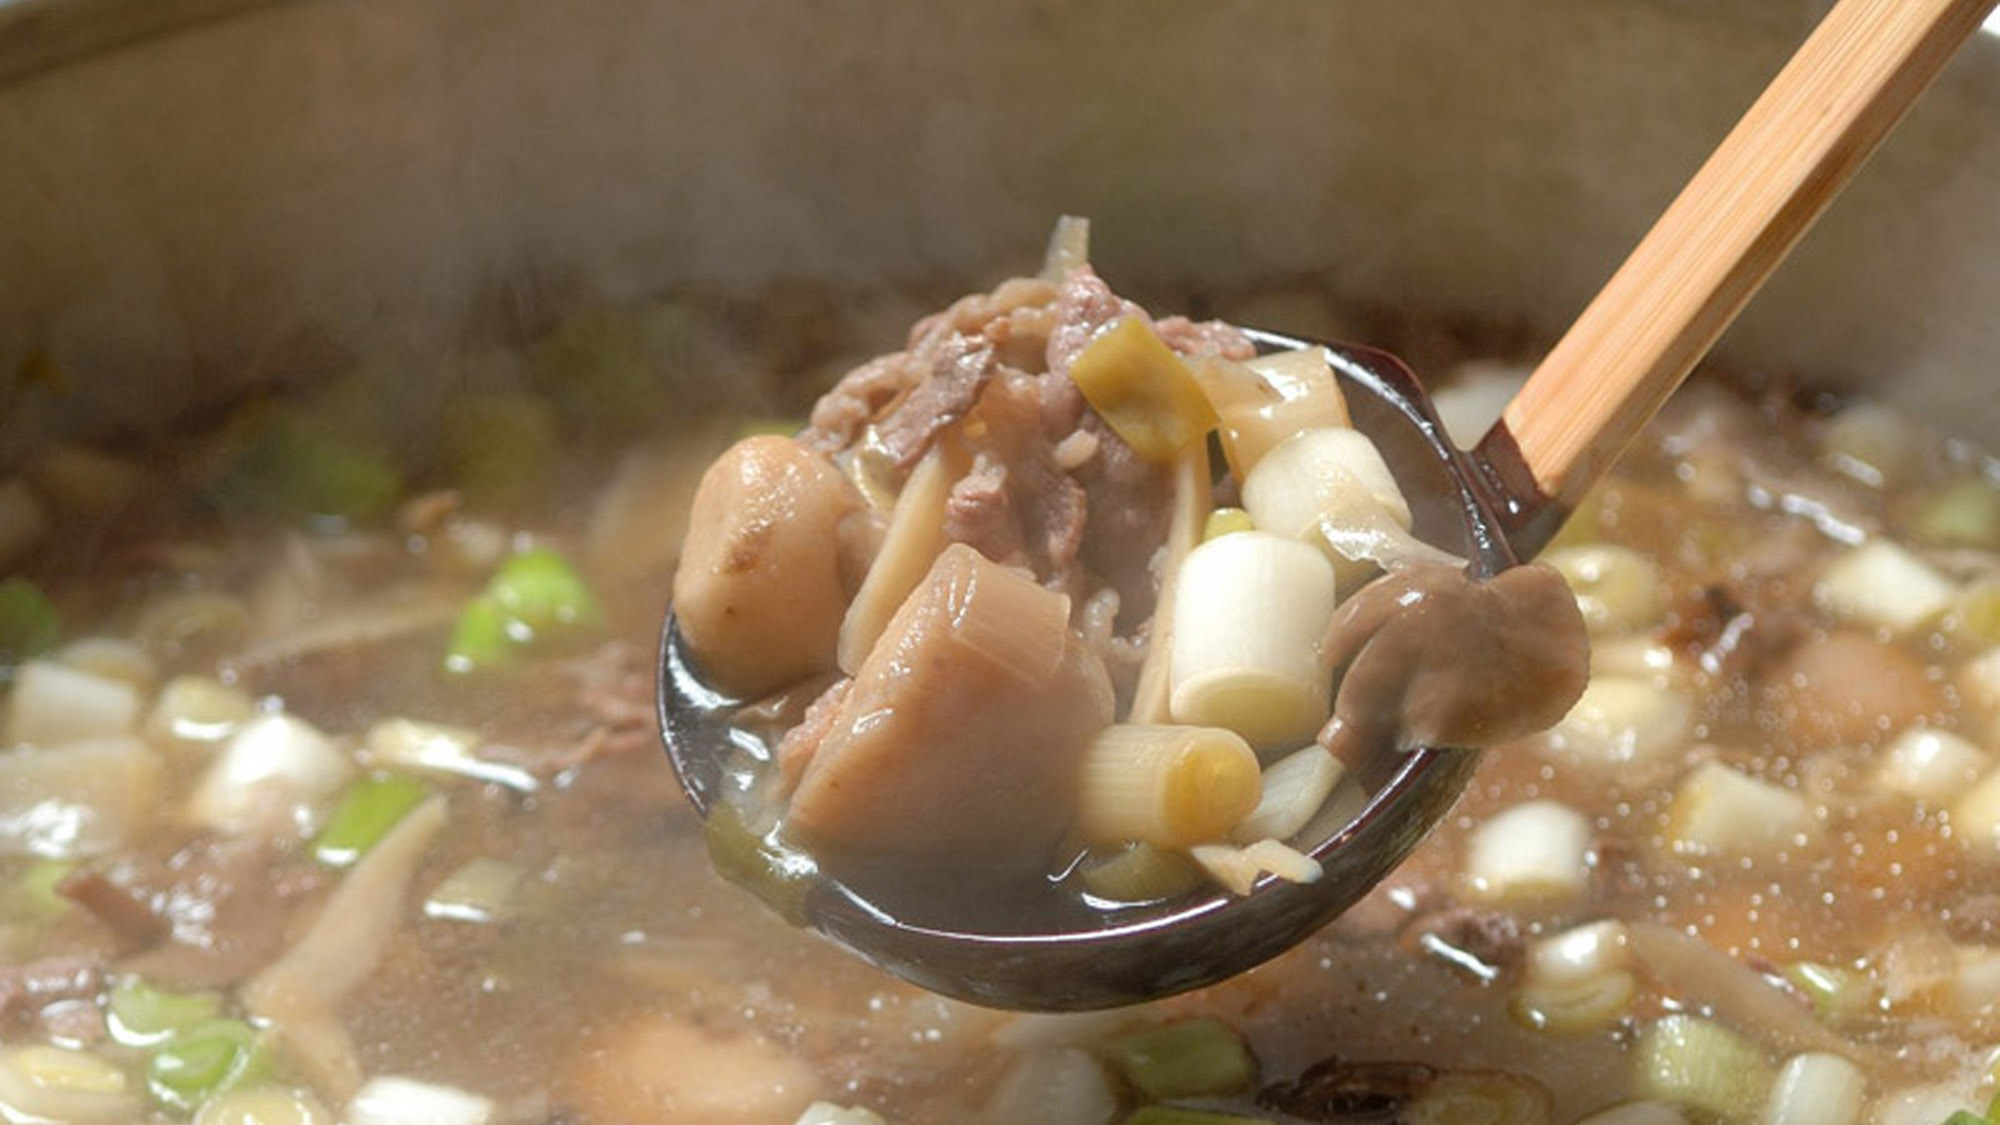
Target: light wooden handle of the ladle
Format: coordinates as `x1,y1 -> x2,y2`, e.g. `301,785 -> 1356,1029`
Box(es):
1474,0 -> 1996,556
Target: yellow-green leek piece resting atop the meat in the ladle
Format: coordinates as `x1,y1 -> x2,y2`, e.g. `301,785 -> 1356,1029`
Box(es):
1070,316 -> 1216,462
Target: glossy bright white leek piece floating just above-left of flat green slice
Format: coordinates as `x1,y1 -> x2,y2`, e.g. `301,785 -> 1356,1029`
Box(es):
188,715 -> 354,835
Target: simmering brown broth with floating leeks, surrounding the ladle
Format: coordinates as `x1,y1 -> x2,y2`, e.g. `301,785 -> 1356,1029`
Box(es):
0,274 -> 2000,1125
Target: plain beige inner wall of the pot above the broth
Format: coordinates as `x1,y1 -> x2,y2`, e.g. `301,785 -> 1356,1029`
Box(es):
0,0 -> 2000,458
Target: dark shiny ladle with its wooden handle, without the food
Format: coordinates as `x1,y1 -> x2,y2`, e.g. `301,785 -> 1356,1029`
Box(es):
660,0 -> 1996,1011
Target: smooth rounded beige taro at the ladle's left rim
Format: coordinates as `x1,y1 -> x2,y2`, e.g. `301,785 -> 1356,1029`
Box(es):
674,434 -> 862,699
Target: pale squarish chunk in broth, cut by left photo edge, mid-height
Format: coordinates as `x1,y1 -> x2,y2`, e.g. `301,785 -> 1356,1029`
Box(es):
0,737 -> 162,859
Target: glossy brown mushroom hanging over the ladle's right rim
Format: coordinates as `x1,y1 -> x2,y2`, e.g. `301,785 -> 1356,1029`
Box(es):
1320,563 -> 1590,761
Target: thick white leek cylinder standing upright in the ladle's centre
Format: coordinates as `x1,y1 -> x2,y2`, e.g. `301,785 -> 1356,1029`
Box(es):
1170,530 -> 1334,747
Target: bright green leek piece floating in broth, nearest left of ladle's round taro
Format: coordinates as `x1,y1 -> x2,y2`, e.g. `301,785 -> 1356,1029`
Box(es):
444,548 -> 604,673
